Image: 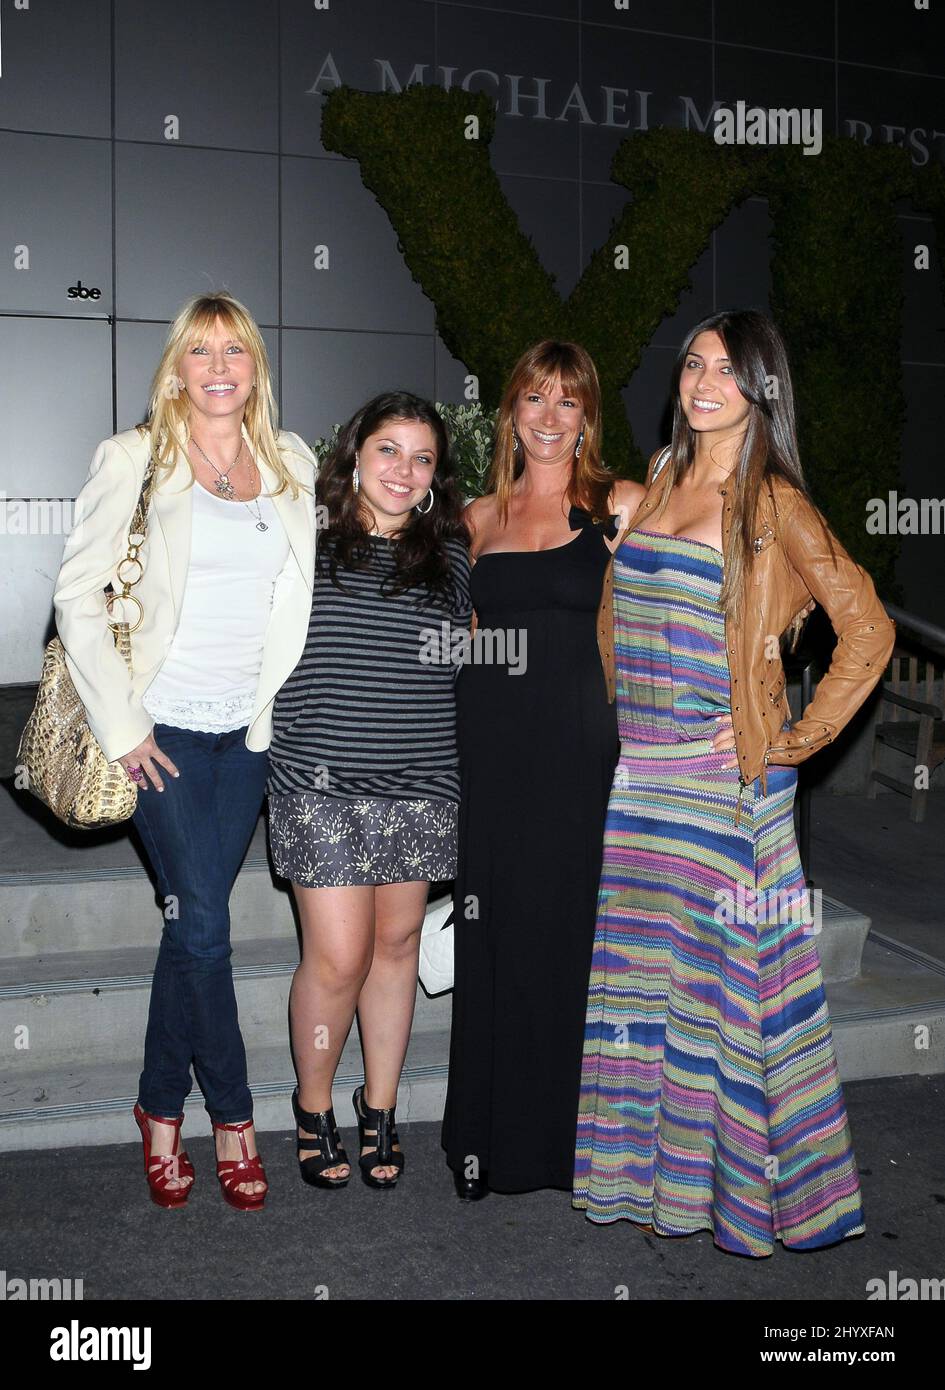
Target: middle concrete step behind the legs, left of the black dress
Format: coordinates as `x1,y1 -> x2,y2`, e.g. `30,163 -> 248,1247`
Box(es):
0,937 -> 450,1076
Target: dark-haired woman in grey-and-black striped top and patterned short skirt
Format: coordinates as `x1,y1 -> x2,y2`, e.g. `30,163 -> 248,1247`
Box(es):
268,392 -> 471,1187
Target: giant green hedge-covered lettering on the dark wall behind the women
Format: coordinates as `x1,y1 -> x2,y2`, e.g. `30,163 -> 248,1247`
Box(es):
322,85 -> 945,598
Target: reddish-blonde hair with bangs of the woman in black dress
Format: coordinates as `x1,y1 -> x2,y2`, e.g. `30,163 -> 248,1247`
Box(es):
488,338 -> 614,525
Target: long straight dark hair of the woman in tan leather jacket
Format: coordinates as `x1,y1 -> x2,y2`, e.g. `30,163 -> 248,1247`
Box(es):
660,309 -> 834,620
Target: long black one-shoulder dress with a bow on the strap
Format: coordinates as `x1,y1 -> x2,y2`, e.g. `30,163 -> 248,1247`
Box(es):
442,507 -> 620,1193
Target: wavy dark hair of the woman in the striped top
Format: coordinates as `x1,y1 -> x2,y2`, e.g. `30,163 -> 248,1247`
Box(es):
315,391 -> 468,595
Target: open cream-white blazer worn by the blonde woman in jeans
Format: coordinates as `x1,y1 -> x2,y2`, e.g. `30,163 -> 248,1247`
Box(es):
53,425 -> 317,760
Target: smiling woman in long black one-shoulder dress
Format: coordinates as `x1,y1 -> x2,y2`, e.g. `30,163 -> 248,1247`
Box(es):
443,342 -> 632,1201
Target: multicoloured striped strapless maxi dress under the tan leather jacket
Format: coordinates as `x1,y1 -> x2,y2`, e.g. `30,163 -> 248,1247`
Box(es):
573,531 -> 864,1255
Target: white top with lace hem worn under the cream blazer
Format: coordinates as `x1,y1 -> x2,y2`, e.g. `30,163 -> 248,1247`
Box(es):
142,482 -> 289,734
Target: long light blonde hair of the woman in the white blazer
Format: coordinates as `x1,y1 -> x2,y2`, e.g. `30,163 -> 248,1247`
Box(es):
138,291 -> 300,498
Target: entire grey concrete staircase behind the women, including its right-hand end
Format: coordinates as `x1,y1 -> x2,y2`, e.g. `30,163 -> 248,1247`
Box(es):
0,796 -> 945,1151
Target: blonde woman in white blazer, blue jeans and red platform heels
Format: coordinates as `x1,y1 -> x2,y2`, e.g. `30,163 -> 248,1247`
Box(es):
54,293 -> 315,1211
